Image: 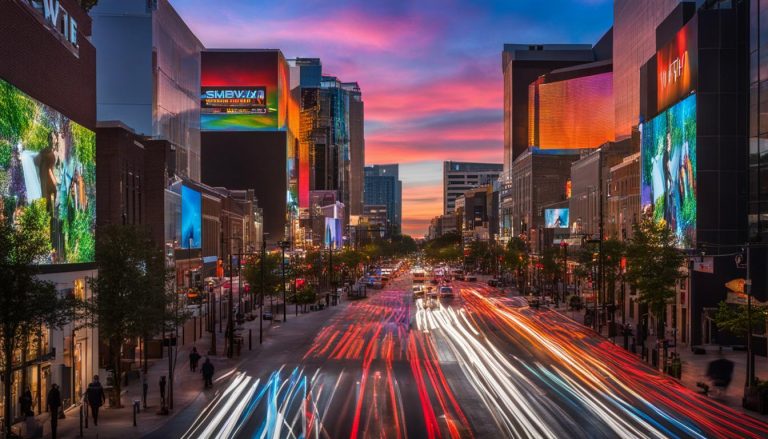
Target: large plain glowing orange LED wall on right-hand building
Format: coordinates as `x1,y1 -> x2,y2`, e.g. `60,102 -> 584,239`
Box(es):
529,72 -> 615,149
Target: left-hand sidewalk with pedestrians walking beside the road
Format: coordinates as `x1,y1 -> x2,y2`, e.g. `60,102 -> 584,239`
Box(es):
18,300 -> 349,439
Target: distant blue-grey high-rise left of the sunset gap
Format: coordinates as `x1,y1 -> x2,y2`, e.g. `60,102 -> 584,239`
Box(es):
364,164 -> 403,233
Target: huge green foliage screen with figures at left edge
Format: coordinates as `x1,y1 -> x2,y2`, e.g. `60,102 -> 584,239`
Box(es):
0,80 -> 96,264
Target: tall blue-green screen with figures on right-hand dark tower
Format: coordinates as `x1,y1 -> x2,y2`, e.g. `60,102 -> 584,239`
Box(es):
640,95 -> 696,248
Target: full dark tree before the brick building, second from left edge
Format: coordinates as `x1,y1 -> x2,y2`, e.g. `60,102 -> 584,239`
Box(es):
92,225 -> 170,406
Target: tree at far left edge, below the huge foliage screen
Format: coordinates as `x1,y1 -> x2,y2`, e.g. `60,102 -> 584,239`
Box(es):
0,217 -> 83,436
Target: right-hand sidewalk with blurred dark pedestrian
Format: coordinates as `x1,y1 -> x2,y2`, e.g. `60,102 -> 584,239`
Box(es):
550,304 -> 768,422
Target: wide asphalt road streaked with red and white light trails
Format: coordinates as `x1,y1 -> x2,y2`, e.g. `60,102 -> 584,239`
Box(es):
151,279 -> 768,438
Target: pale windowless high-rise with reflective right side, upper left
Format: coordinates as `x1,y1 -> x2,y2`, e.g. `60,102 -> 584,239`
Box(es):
90,0 -> 203,181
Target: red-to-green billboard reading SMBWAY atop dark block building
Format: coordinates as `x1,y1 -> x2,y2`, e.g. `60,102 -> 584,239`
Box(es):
200,50 -> 287,131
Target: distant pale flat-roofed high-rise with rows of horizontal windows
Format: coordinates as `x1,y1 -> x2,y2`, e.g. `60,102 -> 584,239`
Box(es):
443,161 -> 504,215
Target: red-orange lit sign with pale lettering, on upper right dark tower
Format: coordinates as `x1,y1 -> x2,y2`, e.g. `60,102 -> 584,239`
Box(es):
656,18 -> 698,112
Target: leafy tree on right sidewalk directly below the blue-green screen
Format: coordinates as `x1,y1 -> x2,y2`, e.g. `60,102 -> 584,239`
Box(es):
625,219 -> 685,334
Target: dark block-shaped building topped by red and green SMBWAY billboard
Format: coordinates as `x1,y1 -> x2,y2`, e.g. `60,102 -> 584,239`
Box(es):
200,49 -> 299,242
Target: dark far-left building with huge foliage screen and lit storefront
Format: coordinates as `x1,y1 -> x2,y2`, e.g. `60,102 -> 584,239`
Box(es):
0,0 -> 102,425
